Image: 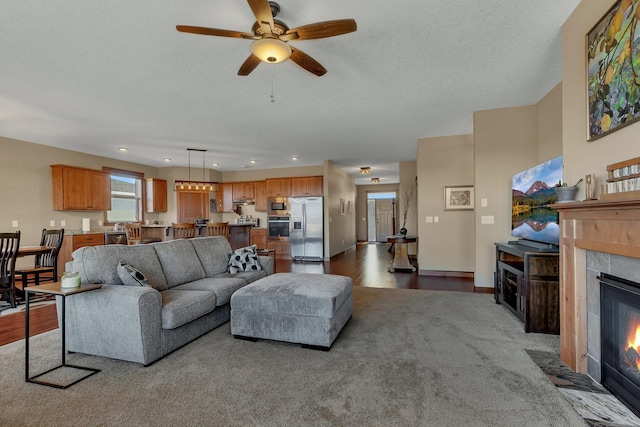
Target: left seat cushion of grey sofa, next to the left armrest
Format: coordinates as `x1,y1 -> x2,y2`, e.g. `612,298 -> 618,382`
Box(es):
160,289 -> 216,329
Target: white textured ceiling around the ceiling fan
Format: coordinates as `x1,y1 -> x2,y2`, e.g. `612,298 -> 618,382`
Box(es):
0,0 -> 580,184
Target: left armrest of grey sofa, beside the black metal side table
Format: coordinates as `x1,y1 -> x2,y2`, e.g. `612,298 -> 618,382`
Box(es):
58,285 -> 162,365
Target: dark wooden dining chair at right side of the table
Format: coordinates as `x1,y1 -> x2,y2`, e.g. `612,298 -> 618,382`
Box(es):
16,228 -> 64,290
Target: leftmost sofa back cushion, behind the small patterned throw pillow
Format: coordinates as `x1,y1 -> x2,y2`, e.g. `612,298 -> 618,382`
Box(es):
72,245 -> 167,291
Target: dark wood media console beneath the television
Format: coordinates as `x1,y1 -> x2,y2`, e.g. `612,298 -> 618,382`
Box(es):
494,242 -> 560,334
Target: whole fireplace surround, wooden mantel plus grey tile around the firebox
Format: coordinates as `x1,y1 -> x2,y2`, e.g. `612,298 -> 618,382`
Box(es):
554,200 -> 640,382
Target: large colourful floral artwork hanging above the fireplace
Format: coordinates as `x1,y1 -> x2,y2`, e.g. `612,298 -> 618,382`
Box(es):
587,0 -> 640,141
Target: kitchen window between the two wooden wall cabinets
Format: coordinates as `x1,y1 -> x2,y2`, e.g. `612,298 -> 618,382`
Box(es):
102,167 -> 144,224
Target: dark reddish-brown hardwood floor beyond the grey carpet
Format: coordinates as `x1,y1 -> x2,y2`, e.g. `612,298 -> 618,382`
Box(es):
0,243 -> 474,345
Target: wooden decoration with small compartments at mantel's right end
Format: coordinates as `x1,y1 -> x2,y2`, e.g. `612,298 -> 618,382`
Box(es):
600,157 -> 640,201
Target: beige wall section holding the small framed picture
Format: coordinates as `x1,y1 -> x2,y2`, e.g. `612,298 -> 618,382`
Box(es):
416,135 -> 474,273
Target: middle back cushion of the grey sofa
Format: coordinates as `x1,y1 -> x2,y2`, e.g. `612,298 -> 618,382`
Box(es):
152,240 -> 205,288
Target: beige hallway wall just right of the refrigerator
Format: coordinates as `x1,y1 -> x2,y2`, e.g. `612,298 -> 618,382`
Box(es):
323,160 -> 357,258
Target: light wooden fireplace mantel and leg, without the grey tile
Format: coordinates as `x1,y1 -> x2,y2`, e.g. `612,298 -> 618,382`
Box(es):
552,200 -> 640,373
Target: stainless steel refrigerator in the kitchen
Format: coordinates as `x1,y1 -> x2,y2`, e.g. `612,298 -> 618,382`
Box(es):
289,197 -> 324,261
